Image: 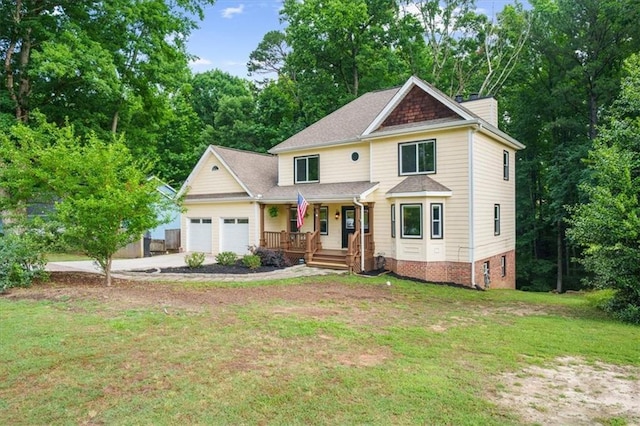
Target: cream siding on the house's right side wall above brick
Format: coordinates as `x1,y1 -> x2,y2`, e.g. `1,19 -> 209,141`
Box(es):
473,133 -> 516,259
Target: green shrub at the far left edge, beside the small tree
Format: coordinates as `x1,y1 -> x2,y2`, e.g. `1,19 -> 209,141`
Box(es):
0,232 -> 47,293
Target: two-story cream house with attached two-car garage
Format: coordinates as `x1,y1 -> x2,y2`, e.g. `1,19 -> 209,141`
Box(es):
181,77 -> 524,288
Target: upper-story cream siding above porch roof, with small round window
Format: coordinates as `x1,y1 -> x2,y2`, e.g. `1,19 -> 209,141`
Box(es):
278,143 -> 369,186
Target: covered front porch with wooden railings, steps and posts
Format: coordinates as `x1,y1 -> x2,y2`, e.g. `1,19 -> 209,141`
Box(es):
259,182 -> 377,273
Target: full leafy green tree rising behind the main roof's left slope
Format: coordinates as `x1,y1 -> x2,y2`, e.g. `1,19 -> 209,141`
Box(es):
281,0 -> 416,124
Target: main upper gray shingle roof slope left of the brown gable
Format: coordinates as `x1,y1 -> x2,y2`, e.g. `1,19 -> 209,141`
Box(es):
269,87 -> 400,154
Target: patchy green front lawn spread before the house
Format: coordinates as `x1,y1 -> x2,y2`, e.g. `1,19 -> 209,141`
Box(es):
0,276 -> 640,425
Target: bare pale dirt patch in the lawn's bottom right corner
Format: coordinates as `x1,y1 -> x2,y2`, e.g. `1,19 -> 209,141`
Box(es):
494,357 -> 640,425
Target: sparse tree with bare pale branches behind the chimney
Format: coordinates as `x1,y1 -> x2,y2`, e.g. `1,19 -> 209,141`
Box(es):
402,0 -> 531,95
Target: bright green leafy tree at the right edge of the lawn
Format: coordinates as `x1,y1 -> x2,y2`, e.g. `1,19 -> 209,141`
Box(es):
569,54 -> 640,324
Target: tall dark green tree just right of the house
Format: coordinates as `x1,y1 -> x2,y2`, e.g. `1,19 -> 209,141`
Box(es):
503,0 -> 640,291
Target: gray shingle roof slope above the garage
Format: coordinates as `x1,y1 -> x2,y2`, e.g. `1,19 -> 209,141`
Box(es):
211,145 -> 278,195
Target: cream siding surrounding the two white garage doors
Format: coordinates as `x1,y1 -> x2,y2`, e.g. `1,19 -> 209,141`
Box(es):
180,202 -> 258,255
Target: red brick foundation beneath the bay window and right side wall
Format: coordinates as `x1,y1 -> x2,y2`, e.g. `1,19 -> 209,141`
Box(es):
385,251 -> 516,289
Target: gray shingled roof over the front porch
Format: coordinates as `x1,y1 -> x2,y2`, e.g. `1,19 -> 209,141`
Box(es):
261,181 -> 379,204
